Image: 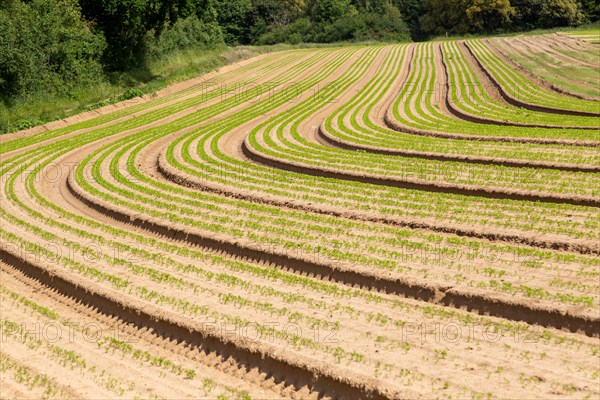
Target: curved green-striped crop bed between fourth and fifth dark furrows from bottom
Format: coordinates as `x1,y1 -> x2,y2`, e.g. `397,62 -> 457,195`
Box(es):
237,48 -> 600,206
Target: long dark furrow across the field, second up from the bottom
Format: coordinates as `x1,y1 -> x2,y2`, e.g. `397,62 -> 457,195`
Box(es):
68,169 -> 600,336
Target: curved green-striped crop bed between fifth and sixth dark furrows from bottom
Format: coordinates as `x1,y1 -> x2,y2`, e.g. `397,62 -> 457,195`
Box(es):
318,43 -> 598,171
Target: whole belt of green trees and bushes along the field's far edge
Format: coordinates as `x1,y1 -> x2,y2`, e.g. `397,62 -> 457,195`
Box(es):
0,0 -> 600,115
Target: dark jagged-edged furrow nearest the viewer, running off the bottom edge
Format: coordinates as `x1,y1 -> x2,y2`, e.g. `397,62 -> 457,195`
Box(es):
0,248 -> 406,399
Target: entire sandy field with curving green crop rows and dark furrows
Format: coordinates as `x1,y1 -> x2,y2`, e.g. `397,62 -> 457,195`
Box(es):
0,33 -> 600,400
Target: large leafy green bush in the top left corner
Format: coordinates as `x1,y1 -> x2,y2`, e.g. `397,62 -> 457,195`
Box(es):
0,0 -> 105,101
